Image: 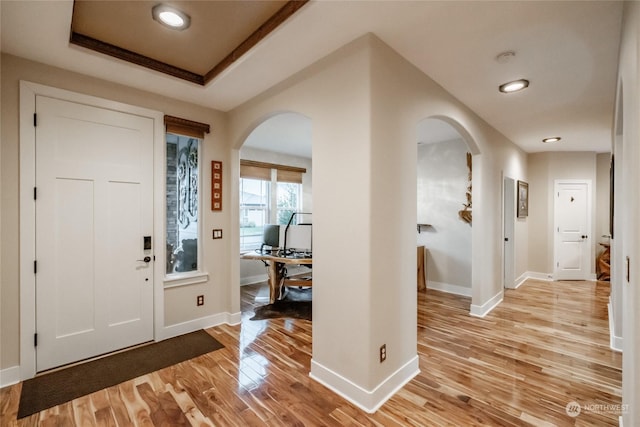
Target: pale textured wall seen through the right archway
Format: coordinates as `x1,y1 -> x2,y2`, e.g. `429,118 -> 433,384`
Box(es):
417,139 -> 471,295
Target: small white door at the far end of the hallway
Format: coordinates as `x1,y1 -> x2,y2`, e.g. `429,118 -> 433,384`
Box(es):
554,181 -> 593,280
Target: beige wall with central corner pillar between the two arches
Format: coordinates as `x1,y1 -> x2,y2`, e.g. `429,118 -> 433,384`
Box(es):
224,35 -> 527,408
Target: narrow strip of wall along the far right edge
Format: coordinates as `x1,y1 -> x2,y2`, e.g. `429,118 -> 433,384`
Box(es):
614,1 -> 640,426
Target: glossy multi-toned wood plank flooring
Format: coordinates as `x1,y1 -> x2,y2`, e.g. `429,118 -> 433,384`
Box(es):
0,280 -> 622,426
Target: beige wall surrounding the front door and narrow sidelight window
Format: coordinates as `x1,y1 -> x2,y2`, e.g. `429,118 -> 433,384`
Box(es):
0,54 -> 231,369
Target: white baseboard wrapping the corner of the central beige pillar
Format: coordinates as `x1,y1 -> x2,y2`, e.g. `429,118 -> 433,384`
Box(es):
309,355 -> 420,414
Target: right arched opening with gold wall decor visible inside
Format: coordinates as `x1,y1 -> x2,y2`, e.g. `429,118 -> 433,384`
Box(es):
416,117 -> 477,306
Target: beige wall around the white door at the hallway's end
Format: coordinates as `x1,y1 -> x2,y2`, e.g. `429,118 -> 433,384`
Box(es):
527,152 -> 599,275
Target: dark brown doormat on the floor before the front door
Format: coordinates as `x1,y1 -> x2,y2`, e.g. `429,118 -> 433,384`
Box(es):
18,330 -> 224,419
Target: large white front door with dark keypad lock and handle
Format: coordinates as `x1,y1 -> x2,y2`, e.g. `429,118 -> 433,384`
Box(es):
35,96 -> 154,371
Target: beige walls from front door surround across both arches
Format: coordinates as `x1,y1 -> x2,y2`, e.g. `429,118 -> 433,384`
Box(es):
1,31 -> 527,406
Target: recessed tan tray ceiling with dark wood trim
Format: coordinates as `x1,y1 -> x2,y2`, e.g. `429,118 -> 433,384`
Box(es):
70,0 -> 307,85
